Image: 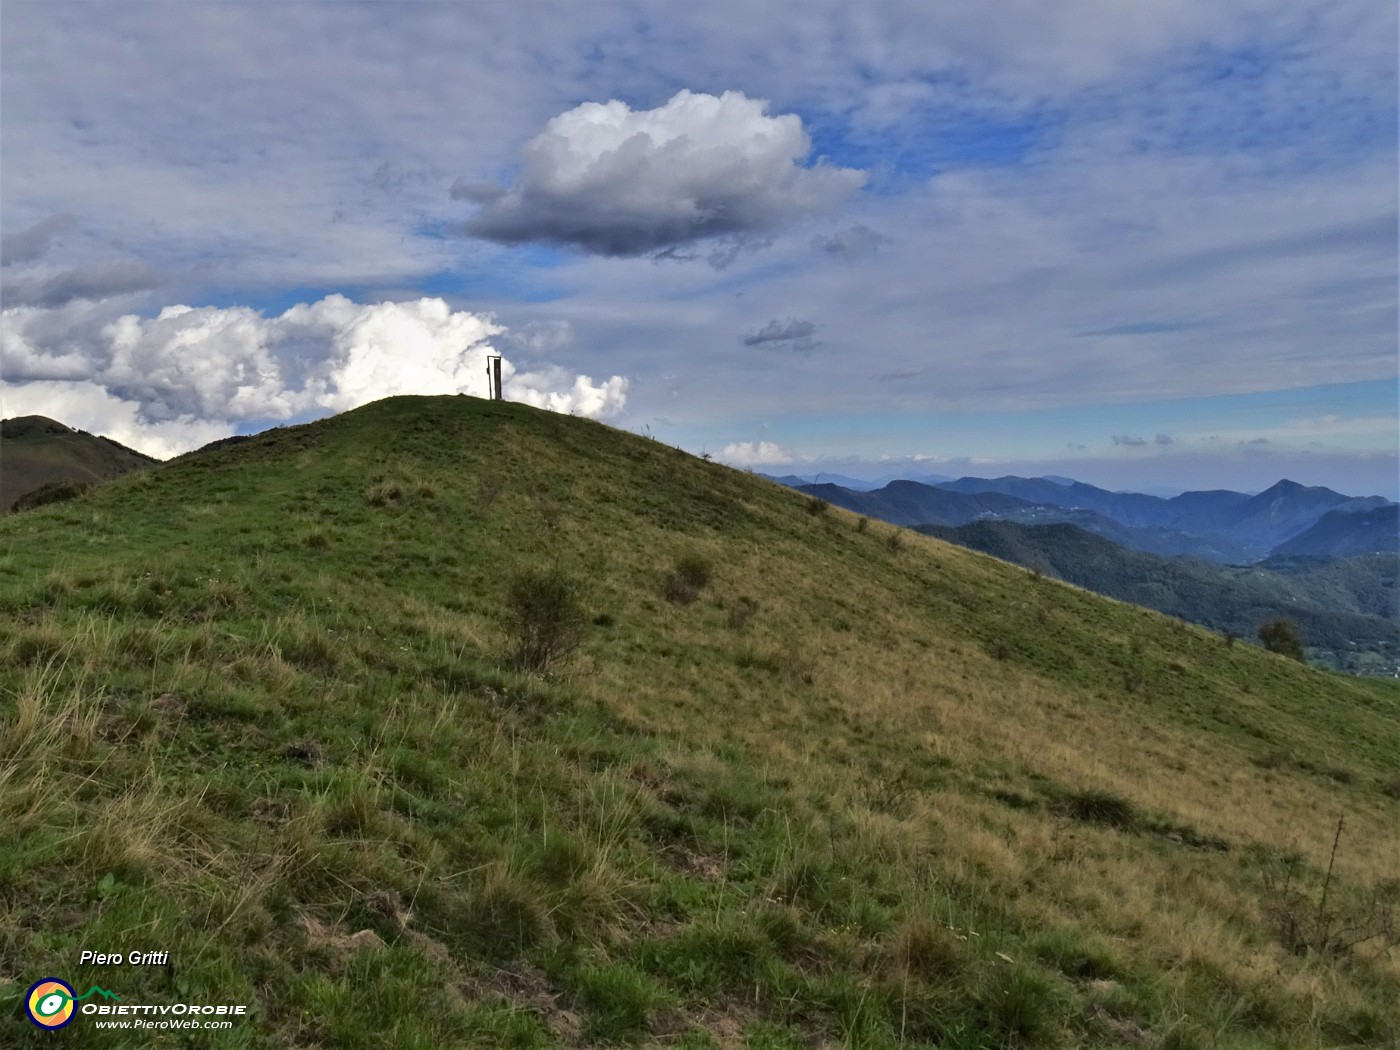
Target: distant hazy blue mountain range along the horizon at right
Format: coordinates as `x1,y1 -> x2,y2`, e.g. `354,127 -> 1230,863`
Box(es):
799,477 -> 1394,564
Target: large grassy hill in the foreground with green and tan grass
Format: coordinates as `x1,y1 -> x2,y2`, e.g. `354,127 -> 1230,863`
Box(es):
0,398 -> 1400,1050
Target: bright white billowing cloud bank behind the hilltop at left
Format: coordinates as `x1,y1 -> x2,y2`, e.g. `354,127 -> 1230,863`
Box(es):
0,295 -> 627,455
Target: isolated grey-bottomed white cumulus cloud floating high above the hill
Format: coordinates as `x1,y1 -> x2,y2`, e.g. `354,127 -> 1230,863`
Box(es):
464,91 -> 865,256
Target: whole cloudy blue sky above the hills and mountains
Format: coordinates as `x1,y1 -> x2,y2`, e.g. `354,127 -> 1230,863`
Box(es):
0,0 -> 1400,498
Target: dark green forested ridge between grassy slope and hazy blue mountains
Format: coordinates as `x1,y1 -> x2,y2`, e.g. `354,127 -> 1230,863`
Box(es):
918,521 -> 1400,673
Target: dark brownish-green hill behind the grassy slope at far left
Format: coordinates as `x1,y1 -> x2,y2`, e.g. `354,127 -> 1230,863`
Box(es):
0,416 -> 160,512
